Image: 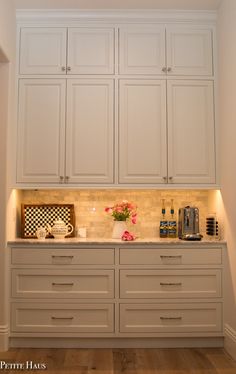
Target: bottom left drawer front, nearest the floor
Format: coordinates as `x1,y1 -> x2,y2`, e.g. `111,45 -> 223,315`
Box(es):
11,303 -> 114,333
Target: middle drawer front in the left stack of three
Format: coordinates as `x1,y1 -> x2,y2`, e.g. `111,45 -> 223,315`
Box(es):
12,269 -> 114,298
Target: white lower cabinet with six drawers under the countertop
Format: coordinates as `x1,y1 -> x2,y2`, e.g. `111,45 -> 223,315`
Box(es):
11,243 -> 224,339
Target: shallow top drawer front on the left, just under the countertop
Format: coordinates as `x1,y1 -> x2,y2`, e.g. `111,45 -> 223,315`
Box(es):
12,248 -> 115,265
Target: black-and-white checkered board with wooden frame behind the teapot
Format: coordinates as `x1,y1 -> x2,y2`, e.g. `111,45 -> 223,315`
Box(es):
21,204 -> 74,238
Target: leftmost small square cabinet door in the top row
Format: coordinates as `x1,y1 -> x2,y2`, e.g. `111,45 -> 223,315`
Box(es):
20,27 -> 67,74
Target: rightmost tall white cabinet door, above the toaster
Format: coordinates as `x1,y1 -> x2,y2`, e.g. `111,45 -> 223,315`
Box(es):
167,80 -> 215,184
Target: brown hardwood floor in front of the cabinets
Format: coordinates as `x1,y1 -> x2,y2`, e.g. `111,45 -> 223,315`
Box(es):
0,348 -> 236,374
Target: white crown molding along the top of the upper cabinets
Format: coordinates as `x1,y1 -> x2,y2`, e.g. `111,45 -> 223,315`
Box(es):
16,9 -> 217,25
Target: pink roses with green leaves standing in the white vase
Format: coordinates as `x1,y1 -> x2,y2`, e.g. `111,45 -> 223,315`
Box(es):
105,200 -> 137,224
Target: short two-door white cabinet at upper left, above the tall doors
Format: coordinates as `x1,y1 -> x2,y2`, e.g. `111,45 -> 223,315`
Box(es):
20,27 -> 114,74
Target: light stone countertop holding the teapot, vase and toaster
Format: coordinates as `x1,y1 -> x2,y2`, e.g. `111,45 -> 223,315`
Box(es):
8,237 -> 226,246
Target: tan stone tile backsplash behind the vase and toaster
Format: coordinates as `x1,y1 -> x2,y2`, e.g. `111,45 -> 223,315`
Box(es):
21,190 -> 209,238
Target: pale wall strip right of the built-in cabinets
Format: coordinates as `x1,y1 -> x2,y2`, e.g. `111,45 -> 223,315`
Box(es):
218,0 -> 236,359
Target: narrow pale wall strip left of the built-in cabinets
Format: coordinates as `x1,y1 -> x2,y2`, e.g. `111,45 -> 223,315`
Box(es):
0,0 -> 15,350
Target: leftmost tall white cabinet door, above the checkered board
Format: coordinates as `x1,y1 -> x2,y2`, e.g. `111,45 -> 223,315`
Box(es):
17,79 -> 66,183
